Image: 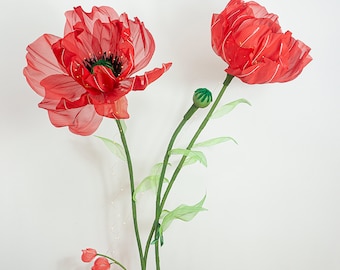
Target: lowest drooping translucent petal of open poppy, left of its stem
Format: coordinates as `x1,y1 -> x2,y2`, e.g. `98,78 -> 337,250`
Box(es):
48,105 -> 103,136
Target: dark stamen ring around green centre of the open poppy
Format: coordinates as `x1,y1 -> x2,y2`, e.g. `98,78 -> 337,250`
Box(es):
84,52 -> 122,77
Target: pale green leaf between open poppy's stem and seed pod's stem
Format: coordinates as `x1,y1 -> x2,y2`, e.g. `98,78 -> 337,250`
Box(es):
133,163 -> 170,201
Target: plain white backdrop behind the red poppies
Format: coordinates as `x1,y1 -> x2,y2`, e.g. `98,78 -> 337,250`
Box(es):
0,0 -> 340,270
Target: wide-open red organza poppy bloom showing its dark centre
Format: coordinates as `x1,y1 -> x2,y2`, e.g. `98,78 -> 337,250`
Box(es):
24,7 -> 171,135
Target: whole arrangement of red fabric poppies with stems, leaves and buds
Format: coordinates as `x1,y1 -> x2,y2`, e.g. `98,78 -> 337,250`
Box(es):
24,0 -> 312,270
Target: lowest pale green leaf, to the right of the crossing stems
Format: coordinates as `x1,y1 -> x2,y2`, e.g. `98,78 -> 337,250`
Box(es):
160,196 -> 207,234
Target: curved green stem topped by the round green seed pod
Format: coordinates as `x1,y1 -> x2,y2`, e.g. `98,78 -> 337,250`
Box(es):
144,105 -> 198,270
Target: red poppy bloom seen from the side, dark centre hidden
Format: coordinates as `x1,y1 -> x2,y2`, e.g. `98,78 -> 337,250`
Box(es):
211,0 -> 312,84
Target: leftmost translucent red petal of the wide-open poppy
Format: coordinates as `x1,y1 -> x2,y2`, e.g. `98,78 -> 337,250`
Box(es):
24,34 -> 65,96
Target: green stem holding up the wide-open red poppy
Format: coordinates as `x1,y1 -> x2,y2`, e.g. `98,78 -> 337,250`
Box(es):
116,120 -> 146,270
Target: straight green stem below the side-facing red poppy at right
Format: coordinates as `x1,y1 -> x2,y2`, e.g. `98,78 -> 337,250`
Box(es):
157,74 -> 234,211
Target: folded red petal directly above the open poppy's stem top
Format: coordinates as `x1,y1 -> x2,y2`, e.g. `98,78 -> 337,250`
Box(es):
94,96 -> 129,119
